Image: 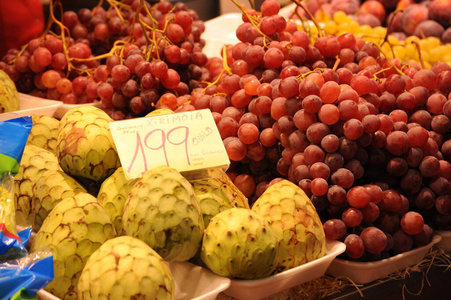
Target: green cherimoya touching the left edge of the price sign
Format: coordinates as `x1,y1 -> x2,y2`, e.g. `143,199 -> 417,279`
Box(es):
56,105 -> 120,182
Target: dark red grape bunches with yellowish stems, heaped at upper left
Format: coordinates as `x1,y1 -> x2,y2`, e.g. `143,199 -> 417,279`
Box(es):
0,0 -> 220,120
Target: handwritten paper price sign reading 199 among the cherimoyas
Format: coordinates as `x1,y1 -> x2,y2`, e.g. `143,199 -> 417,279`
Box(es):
110,109 -> 230,179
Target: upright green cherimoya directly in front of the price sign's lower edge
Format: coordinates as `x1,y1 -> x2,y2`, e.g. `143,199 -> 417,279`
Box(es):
122,166 -> 204,261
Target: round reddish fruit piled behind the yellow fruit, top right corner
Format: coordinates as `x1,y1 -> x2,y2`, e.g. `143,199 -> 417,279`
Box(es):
296,0 -> 451,43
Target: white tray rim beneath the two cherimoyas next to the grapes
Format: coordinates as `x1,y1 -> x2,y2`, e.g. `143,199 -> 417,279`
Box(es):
224,241 -> 346,300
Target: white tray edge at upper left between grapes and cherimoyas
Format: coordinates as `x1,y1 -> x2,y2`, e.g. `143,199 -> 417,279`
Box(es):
15,93 -> 63,116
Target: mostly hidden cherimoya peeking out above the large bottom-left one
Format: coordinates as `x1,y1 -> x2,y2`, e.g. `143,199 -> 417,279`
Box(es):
29,170 -> 87,232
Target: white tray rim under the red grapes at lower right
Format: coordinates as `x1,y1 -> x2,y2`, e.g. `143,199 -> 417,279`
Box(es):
326,235 -> 442,284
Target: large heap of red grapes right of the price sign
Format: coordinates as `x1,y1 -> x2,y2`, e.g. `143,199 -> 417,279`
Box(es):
163,0 -> 451,260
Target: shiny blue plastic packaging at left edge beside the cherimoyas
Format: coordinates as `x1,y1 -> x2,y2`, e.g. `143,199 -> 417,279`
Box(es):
0,115 -> 53,299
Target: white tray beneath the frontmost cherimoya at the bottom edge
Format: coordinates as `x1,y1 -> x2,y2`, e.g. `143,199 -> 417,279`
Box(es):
38,262 -> 230,300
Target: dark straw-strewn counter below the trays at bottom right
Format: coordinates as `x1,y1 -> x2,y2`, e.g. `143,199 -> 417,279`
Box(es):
216,241 -> 451,300
